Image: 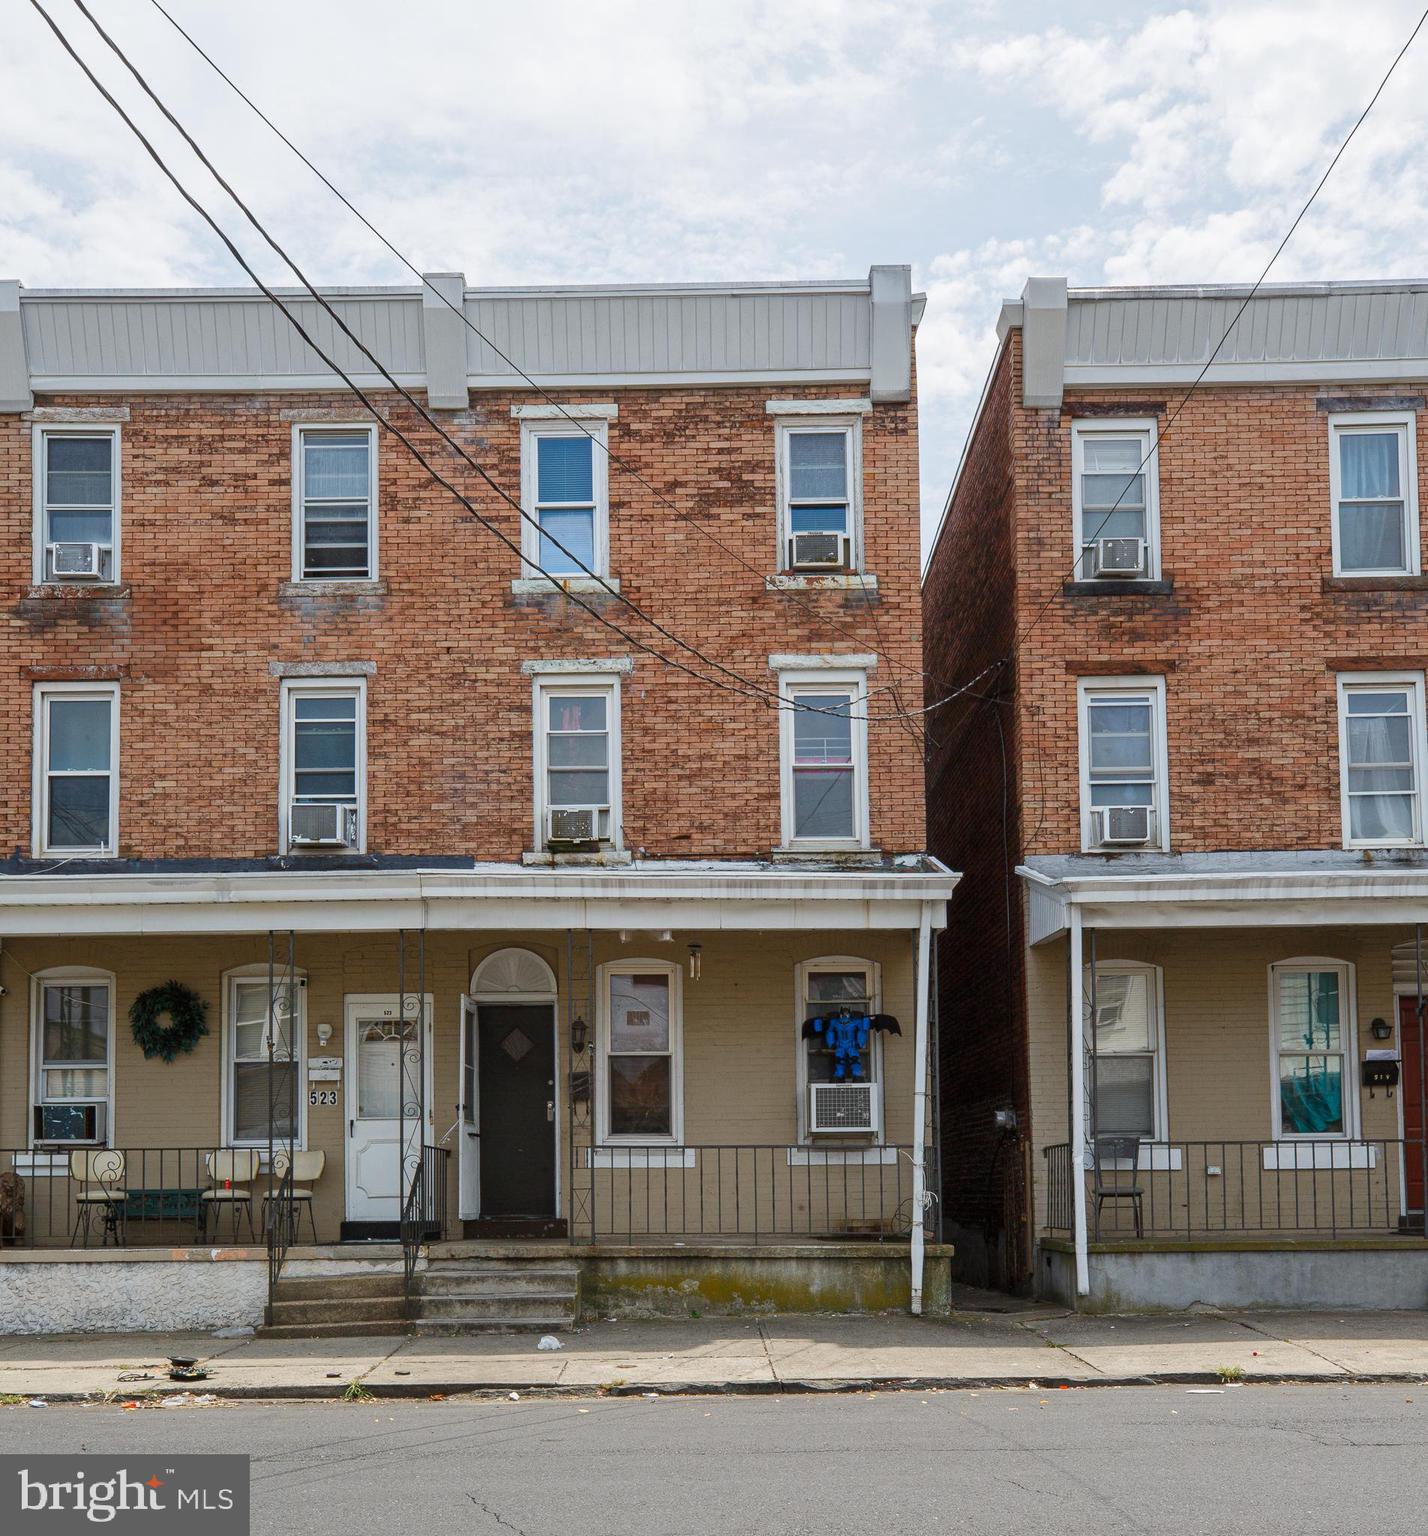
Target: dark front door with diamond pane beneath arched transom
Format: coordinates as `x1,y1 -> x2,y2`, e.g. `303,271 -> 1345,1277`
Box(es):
476,1003 -> 556,1220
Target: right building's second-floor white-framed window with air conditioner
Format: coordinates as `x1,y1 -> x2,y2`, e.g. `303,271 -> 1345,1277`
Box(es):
1076,677 -> 1170,852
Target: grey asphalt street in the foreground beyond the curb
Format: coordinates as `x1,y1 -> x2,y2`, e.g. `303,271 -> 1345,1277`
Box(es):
0,1385 -> 1428,1536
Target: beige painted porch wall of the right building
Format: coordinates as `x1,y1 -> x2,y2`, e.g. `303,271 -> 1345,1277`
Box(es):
1027,928 -> 1413,1230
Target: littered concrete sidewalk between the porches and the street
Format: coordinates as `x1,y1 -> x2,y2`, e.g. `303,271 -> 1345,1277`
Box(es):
0,1309 -> 1428,1402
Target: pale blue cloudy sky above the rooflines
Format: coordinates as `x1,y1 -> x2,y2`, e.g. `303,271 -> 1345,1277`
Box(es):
0,0 -> 1428,552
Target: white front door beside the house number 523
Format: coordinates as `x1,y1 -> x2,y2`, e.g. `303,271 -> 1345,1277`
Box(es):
344,994 -> 433,1221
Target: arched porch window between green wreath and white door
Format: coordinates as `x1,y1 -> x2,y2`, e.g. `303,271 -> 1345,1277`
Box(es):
223,965 -> 307,1146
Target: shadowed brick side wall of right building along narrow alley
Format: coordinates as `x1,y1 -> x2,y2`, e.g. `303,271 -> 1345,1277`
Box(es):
923,333 -> 1029,1284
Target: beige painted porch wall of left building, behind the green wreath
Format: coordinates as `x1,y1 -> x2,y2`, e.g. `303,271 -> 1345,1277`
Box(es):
0,932 -> 915,1238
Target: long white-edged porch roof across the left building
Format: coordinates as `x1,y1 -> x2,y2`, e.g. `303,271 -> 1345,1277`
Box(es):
0,854 -> 960,937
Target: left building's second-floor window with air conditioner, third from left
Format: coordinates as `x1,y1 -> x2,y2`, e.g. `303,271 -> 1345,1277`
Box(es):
536,674 -> 620,849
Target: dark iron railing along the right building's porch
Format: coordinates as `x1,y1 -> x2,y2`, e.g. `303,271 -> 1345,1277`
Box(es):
1043,1137 -> 1423,1241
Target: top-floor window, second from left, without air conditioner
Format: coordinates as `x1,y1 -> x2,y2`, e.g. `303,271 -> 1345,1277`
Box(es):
293,425 -> 376,581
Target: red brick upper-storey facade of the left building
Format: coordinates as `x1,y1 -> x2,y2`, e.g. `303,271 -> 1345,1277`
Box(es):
0,387 -> 924,859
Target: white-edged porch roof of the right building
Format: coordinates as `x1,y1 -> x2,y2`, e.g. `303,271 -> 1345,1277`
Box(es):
1016,848 -> 1428,945
